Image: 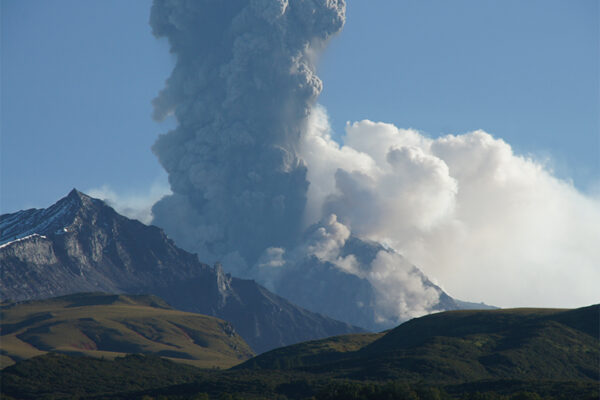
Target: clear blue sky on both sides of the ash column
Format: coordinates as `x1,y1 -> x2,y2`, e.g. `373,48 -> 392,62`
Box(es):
0,0 -> 600,212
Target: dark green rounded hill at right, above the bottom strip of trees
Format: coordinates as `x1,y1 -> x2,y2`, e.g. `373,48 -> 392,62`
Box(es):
238,305 -> 600,383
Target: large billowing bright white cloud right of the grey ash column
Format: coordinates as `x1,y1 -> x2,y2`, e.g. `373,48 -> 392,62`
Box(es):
301,107 -> 600,306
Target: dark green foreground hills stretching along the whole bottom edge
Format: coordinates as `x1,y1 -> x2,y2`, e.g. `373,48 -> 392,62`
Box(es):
2,305 -> 600,400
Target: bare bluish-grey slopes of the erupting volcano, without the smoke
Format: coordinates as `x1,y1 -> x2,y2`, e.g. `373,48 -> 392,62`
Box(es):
257,236 -> 464,332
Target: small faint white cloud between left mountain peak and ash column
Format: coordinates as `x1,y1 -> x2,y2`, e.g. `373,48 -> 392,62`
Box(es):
86,177 -> 171,225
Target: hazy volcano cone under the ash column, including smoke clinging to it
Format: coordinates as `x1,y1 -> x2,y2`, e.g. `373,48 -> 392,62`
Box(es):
249,231 -> 495,332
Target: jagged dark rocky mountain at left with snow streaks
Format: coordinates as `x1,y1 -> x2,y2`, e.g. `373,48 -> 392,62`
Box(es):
0,189 -> 361,352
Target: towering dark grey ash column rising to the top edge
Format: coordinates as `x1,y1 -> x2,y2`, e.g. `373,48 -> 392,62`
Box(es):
150,0 -> 345,273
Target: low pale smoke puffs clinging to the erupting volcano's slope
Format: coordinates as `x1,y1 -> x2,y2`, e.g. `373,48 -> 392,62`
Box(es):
282,214 -> 441,324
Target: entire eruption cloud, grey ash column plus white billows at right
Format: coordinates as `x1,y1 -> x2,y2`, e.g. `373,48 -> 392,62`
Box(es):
151,0 -> 600,326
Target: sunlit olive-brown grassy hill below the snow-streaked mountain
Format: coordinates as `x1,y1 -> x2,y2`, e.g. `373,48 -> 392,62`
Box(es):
0,293 -> 253,368
